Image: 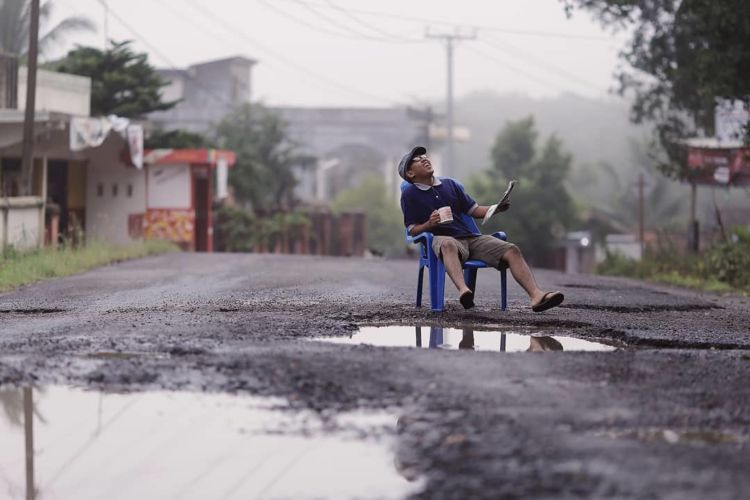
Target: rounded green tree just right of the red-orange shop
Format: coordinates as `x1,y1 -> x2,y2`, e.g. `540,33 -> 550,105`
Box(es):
216,104 -> 311,212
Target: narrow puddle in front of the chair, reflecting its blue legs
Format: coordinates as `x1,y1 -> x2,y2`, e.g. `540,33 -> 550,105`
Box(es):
314,326 -> 616,352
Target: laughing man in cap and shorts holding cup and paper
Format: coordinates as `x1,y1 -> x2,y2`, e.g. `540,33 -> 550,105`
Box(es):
398,146 -> 564,312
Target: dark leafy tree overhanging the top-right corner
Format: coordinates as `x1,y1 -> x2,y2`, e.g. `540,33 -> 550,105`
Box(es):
561,0 -> 750,177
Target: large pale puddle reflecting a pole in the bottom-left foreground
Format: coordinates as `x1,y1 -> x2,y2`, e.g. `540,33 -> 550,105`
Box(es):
0,387 -> 421,500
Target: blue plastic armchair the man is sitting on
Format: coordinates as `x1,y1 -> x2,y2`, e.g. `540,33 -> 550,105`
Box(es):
401,181 -> 508,311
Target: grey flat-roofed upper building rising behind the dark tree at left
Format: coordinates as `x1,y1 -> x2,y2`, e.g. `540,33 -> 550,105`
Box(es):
148,56 -> 256,133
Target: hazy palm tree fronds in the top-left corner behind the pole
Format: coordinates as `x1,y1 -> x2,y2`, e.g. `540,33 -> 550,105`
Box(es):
0,0 -> 96,56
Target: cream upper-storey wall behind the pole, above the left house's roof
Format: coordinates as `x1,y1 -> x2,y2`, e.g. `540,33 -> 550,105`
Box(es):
18,66 -> 91,116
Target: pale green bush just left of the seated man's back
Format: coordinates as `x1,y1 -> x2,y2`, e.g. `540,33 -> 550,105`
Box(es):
331,175 -> 404,255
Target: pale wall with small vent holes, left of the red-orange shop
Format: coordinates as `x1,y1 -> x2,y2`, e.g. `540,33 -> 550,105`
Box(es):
86,136 -> 146,244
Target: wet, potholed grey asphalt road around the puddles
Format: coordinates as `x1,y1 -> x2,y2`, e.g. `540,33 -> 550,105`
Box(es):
0,254 -> 750,499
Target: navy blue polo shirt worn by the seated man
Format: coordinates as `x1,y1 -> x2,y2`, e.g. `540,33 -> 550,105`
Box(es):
401,177 -> 480,238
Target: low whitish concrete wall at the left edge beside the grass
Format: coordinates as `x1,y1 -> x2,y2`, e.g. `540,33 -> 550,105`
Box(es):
0,196 -> 44,250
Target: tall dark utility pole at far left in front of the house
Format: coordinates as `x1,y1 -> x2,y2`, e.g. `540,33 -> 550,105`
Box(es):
21,0 -> 39,196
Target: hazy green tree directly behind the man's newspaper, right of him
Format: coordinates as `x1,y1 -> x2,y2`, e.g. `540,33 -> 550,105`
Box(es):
469,117 -> 577,262
